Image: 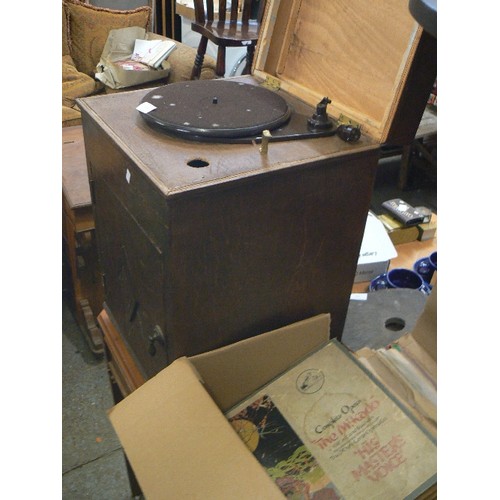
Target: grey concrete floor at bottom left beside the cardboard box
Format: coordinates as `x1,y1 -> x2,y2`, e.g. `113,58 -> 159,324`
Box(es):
62,296 -> 132,500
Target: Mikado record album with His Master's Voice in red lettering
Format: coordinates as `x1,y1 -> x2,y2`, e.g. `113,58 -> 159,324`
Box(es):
227,340 -> 437,500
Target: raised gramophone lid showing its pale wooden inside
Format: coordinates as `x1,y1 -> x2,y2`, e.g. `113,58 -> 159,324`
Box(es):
253,0 -> 435,143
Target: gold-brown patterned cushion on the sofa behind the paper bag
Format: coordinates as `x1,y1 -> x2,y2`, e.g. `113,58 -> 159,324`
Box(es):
63,0 -> 151,77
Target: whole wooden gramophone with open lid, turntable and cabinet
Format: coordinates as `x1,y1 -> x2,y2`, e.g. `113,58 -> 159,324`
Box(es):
78,0 -> 435,378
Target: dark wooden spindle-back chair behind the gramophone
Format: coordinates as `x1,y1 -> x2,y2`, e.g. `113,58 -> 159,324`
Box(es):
191,0 -> 265,80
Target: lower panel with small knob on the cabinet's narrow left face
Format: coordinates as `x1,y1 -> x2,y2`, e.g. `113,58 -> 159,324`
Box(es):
94,180 -> 169,378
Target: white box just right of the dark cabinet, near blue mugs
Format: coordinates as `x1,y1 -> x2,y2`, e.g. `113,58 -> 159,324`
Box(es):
354,212 -> 398,283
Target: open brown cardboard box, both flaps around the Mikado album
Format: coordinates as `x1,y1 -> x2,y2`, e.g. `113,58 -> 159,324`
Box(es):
109,314 -> 330,500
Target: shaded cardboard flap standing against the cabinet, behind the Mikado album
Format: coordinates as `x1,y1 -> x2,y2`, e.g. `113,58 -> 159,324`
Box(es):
189,314 -> 330,411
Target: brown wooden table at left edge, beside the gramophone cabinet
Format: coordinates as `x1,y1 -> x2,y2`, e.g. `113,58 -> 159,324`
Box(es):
62,126 -> 104,355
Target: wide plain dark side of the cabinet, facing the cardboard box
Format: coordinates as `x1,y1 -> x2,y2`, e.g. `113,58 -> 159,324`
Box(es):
167,152 -> 377,355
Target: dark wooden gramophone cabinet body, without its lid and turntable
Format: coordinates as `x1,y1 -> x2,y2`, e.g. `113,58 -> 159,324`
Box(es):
81,82 -> 379,378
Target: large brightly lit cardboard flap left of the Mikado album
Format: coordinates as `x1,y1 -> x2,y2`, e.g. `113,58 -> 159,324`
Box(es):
109,358 -> 282,500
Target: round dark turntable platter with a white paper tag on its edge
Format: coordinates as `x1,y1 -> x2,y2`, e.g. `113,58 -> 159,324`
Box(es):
137,80 -> 335,143
